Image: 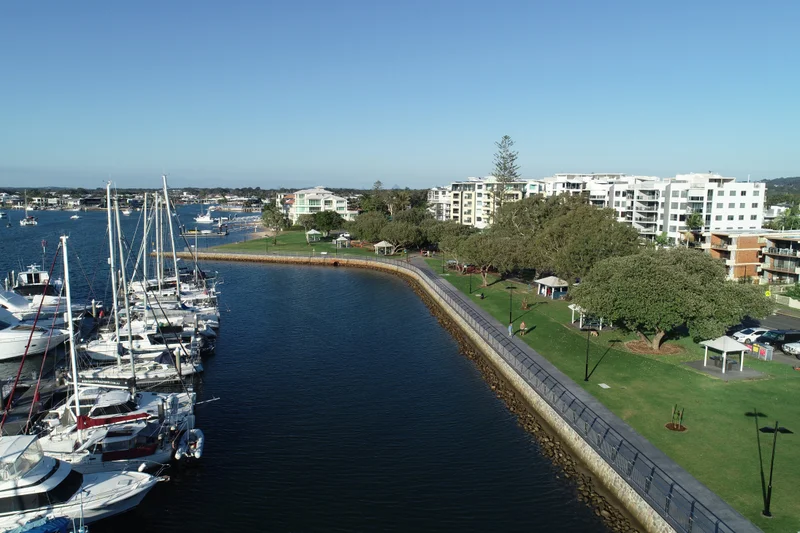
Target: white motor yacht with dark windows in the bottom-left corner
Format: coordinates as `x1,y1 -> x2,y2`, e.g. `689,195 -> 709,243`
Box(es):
0,435 -> 166,531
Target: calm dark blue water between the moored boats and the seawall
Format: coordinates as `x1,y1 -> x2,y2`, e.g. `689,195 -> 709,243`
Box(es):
0,208 -> 604,533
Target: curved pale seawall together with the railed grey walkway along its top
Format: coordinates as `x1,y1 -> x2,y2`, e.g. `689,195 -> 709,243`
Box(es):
184,252 -> 760,533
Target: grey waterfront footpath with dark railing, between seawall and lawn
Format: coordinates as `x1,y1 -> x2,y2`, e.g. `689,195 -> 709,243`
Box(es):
410,257 -> 761,532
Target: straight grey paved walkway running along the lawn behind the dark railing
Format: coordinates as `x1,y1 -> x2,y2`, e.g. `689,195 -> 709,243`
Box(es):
411,256 -> 760,532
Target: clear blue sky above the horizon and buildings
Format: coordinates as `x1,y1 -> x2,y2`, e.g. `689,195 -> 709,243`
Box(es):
0,0 -> 800,188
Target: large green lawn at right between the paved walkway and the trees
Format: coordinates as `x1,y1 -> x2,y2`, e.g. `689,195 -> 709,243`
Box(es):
428,260 -> 800,531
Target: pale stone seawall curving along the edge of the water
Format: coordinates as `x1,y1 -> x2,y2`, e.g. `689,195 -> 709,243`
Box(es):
184,252 -> 759,533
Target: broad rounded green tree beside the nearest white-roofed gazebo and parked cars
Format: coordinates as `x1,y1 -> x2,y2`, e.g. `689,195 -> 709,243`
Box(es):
571,248 -> 773,350
